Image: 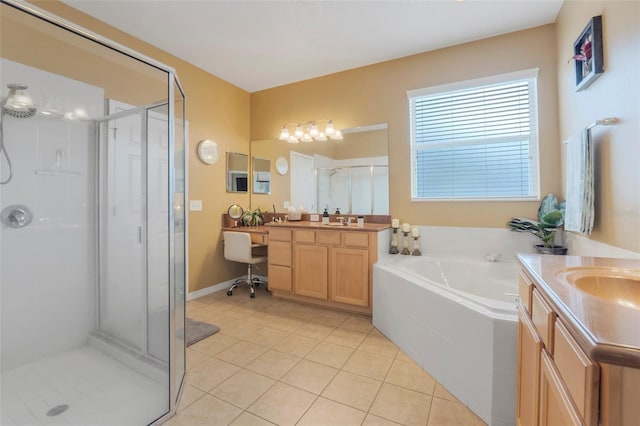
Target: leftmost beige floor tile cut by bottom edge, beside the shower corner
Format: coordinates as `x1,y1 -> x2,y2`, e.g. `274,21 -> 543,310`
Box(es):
169,395 -> 242,426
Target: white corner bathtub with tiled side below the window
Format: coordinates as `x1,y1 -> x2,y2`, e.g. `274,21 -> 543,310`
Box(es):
373,255 -> 518,426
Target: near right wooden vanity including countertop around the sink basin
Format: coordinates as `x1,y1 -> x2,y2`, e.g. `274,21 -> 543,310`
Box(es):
516,255 -> 640,426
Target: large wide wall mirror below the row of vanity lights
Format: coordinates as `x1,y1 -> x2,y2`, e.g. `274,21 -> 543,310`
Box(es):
251,123 -> 389,215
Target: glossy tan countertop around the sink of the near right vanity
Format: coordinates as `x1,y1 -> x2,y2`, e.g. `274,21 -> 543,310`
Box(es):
518,254 -> 640,368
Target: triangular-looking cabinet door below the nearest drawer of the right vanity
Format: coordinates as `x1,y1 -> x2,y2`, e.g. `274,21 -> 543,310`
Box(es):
540,350 -> 583,426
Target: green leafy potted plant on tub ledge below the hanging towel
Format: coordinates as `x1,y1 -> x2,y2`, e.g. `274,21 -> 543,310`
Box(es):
507,194 -> 567,254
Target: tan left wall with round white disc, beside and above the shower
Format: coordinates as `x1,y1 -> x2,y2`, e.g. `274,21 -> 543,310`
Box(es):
9,1 -> 250,291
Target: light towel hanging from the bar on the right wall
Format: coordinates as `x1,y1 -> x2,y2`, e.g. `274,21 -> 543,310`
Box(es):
564,129 -> 595,235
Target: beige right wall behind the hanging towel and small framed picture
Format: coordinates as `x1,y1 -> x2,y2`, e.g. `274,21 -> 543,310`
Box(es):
556,1 -> 640,252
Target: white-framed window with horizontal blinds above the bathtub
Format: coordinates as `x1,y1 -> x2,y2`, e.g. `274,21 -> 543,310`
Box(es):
407,70 -> 539,201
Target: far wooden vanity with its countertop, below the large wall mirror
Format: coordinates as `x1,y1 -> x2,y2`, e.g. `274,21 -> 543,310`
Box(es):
267,222 -> 389,313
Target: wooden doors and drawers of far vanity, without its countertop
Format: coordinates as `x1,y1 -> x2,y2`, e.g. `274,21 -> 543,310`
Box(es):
269,228 -> 378,313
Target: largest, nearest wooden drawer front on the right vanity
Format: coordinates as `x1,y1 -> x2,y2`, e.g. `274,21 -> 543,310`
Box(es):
553,321 -> 599,425
